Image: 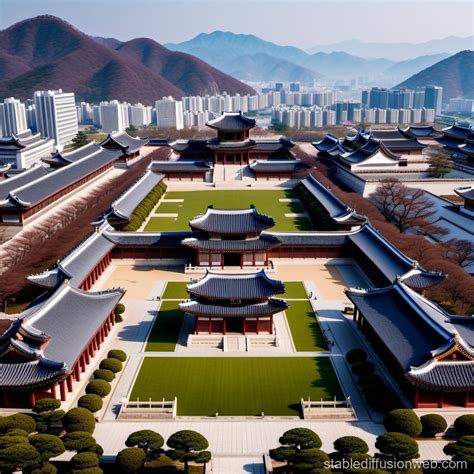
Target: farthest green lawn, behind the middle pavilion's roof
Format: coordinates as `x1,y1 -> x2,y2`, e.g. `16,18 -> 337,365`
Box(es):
145,190 -> 313,232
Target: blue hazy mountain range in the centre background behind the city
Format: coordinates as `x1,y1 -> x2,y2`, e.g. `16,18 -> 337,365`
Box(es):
166,31 -> 470,85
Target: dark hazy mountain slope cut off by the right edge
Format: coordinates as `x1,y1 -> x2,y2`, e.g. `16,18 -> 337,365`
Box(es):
398,51 -> 474,101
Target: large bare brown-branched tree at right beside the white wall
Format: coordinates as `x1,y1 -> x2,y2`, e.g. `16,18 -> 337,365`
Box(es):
371,178 -> 443,234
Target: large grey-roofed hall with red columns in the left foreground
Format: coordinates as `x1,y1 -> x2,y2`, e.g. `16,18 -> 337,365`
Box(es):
0,280 -> 124,408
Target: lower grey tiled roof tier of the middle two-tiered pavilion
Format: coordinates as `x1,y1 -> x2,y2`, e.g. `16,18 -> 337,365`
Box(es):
181,235 -> 280,252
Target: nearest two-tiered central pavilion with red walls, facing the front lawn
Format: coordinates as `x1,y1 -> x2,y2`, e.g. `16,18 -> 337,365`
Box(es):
179,270 -> 288,335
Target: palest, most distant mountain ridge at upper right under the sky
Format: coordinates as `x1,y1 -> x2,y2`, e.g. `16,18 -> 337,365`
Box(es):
307,36 -> 474,61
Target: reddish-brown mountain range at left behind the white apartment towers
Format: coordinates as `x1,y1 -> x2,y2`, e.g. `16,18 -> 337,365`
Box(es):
0,15 -> 255,104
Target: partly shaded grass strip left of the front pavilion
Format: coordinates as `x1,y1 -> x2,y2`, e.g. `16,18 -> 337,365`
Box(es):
145,301 -> 184,352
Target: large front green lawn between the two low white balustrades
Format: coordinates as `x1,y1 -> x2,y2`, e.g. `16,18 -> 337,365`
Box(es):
130,357 -> 343,416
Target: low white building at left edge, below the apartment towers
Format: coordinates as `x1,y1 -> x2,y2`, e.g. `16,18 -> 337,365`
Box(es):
0,129 -> 54,170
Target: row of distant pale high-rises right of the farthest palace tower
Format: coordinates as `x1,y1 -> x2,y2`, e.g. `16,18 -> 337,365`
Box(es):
272,102 -> 435,129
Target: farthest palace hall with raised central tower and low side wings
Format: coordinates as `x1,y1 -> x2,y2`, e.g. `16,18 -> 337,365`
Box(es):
153,112 -> 310,180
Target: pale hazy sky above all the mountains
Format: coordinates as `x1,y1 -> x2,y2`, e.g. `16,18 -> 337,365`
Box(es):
0,0 -> 474,48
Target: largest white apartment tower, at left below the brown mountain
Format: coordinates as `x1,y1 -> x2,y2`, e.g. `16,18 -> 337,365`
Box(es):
34,89 -> 78,145
